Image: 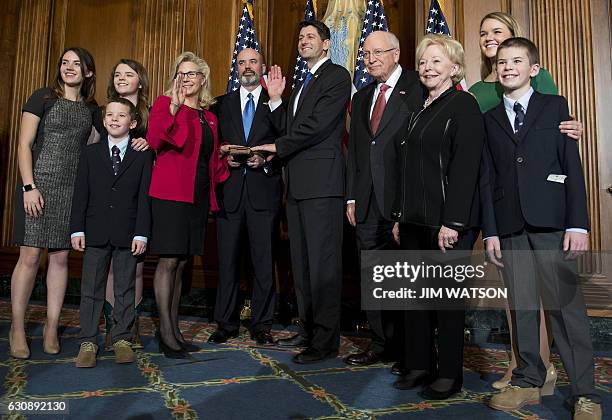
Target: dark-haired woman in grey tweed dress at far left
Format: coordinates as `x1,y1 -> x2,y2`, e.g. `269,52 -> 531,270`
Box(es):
9,48 -> 97,359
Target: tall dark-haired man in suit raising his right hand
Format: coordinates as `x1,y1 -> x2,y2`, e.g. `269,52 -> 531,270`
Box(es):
256,21 -> 351,363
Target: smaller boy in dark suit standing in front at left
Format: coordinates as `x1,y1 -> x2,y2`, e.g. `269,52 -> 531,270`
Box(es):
70,98 -> 153,367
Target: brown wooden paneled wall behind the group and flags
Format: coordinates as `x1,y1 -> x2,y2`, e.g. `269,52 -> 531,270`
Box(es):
0,0 -> 612,308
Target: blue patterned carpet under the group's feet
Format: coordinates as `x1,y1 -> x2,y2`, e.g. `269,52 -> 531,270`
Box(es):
0,301 -> 612,420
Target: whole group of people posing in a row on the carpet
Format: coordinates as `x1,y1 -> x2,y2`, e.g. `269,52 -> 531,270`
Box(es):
9,12 -> 601,419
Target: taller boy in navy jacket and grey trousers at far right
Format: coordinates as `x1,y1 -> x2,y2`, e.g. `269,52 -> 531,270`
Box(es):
483,38 -> 601,419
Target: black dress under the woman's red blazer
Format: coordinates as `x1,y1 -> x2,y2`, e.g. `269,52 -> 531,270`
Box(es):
149,112 -> 214,255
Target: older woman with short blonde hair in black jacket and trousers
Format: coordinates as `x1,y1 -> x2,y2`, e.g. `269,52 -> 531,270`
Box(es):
394,35 -> 484,399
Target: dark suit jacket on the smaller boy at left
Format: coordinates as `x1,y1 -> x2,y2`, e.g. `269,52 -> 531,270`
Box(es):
70,139 -> 153,247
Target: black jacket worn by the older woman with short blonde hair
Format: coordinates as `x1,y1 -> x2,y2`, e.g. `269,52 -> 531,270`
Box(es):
392,87 -> 484,231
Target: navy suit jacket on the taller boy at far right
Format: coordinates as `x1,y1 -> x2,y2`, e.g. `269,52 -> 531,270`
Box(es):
482,92 -> 589,237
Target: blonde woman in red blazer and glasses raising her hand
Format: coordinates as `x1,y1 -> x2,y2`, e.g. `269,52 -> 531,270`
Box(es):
147,52 -> 229,358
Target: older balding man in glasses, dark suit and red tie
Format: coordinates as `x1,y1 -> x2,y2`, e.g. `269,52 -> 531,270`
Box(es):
345,31 -> 423,374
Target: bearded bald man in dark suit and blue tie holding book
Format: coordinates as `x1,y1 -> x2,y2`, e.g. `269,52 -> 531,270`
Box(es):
208,48 -> 280,345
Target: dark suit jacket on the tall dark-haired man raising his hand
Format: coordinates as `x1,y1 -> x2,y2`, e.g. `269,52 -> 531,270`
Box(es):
272,60 -> 351,200
